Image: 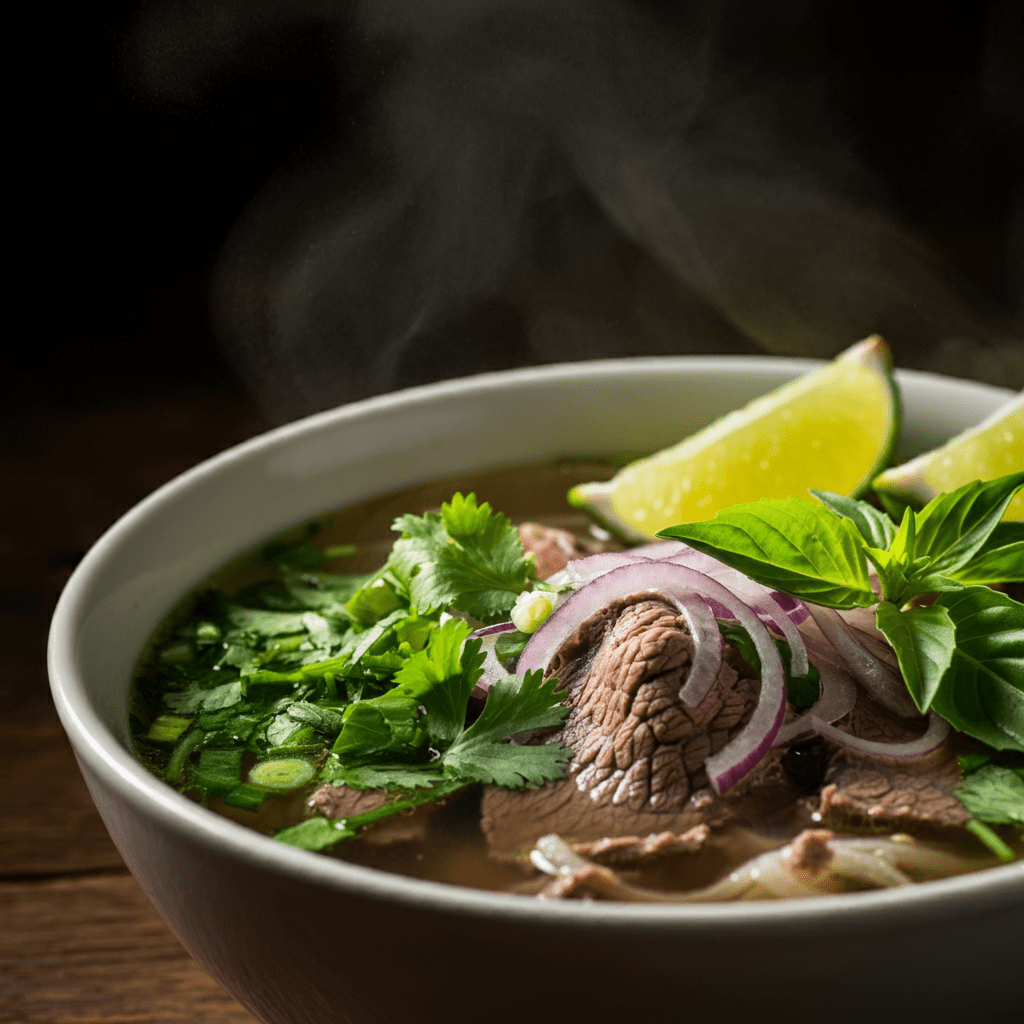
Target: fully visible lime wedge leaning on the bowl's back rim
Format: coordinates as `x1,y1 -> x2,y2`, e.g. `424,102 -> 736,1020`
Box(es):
568,335 -> 900,540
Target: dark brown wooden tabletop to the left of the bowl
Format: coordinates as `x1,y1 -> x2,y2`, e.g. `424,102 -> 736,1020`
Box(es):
0,382 -> 266,1024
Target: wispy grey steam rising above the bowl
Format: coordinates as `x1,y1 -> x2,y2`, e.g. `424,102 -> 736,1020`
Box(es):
125,0 -> 1024,420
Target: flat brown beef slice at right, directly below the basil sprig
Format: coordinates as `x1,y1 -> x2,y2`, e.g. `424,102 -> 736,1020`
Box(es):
817,696 -> 970,833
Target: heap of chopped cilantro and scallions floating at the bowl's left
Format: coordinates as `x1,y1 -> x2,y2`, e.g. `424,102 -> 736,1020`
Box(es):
134,494 -> 571,849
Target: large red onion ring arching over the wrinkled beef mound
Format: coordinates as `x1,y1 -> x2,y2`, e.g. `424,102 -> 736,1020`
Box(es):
517,561 -> 785,794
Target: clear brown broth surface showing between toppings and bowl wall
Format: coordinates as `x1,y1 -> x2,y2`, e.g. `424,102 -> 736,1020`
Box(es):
136,462 -> 1022,898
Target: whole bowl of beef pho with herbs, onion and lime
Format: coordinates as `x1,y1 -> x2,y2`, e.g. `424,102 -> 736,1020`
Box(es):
49,348 -> 1024,1024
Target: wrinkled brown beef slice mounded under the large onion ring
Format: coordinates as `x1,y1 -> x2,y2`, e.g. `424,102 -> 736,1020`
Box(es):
482,594 -> 798,856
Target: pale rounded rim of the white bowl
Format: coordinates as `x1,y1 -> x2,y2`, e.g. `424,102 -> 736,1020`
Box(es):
47,355 -> 1024,934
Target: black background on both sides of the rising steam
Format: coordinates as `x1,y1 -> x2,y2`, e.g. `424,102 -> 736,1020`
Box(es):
4,0 -> 1024,415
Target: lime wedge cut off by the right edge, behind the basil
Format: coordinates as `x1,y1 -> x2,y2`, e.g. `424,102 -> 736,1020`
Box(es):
871,392 -> 1024,522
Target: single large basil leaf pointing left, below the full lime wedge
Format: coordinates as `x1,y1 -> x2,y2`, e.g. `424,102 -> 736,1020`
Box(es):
657,498 -> 878,608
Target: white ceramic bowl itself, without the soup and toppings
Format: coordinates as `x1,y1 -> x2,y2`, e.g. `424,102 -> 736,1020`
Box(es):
49,357 -> 1024,1024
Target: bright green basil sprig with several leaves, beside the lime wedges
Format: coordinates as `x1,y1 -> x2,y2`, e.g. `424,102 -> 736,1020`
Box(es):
659,473 -> 1024,751
